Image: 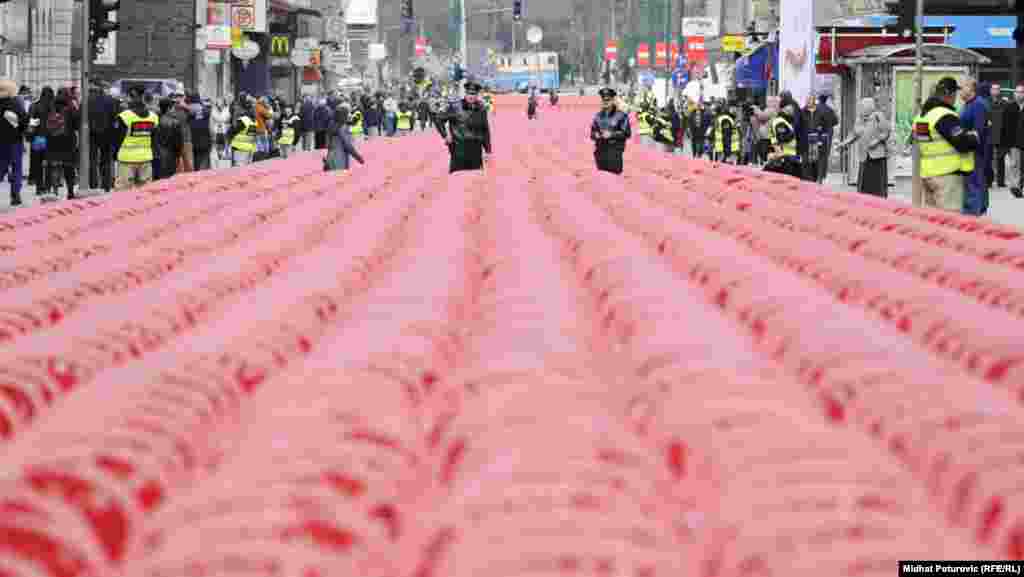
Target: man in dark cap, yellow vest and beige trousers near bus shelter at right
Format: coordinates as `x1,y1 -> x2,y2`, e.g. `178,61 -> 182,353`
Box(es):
913,77 -> 978,212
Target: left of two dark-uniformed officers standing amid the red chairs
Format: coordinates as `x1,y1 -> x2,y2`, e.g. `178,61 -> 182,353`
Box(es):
435,80 -> 492,173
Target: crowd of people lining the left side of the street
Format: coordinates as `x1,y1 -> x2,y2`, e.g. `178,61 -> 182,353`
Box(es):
0,75 -> 493,206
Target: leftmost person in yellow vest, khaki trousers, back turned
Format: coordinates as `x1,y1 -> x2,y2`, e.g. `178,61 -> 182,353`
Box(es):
115,86 -> 160,191
